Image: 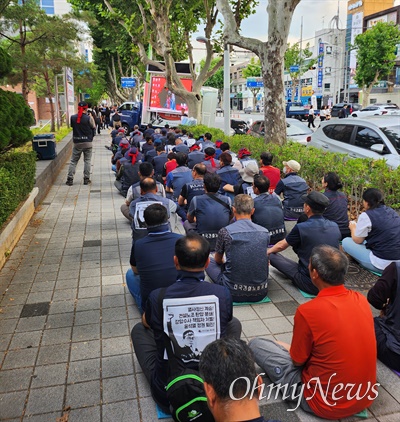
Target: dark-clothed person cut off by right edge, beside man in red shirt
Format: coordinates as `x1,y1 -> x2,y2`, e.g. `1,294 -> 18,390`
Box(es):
367,262 -> 400,372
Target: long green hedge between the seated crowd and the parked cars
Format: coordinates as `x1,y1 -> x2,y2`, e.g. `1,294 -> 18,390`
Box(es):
186,126 -> 400,211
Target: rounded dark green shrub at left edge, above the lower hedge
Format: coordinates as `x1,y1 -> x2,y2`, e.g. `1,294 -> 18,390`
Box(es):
0,89 -> 34,152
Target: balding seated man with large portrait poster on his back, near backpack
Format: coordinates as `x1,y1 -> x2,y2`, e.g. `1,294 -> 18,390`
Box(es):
132,233 -> 241,412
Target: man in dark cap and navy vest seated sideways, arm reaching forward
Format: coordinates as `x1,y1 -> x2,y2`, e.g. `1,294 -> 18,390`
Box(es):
268,191 -> 342,295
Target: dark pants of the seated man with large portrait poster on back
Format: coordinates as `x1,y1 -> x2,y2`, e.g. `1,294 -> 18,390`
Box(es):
131,317 -> 242,412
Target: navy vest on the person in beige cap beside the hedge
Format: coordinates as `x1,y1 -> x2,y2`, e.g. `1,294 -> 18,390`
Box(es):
282,173 -> 308,218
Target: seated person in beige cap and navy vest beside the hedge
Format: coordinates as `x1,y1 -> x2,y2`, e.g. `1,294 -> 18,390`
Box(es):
275,160 -> 308,220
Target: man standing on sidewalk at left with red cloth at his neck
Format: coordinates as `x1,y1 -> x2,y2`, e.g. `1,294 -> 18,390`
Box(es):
66,101 -> 96,186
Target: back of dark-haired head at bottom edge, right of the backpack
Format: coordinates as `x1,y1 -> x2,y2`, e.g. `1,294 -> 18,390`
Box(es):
199,338 -> 272,422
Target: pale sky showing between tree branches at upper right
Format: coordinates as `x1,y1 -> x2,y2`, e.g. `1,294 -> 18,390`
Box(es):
194,0 -> 400,59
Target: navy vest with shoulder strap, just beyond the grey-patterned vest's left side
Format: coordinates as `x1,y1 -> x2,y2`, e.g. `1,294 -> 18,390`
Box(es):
193,194 -> 231,250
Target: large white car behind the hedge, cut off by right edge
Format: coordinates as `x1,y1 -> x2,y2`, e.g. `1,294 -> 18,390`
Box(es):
308,116 -> 400,168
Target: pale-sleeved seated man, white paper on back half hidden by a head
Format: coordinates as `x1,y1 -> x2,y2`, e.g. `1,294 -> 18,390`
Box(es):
129,177 -> 176,242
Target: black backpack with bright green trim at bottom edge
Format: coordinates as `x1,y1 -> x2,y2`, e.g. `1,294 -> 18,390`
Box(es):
158,289 -> 214,422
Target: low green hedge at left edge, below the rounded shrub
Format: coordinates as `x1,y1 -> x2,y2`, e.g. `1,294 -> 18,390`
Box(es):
0,151 -> 36,227
